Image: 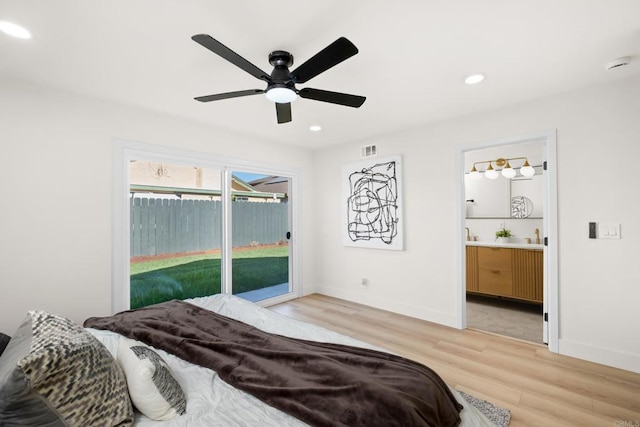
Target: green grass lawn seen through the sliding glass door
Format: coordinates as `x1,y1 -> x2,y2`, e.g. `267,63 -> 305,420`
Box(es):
131,246 -> 289,308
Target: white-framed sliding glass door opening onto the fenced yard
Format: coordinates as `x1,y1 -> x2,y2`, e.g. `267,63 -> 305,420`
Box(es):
121,150 -> 295,311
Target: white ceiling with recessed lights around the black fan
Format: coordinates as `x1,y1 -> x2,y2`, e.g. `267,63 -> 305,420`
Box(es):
0,0 -> 640,148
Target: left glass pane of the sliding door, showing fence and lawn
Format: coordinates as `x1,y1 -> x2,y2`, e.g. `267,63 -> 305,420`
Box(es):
129,160 -> 222,308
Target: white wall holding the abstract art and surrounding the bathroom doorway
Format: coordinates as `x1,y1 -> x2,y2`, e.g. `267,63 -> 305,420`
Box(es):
315,77 -> 640,372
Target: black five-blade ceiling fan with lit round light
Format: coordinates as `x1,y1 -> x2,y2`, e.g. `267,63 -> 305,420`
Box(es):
191,34 -> 366,123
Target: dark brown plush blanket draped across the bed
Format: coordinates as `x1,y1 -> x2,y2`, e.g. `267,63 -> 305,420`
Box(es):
84,300 -> 462,427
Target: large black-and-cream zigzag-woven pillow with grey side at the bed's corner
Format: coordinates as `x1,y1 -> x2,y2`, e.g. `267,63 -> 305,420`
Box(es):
0,311 -> 133,427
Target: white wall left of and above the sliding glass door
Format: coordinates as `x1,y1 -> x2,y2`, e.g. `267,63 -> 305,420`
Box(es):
0,80 -> 314,334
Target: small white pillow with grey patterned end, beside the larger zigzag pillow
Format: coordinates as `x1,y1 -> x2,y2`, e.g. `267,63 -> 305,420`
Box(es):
117,337 -> 187,421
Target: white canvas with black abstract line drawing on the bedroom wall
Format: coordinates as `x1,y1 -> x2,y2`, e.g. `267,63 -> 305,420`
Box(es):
342,155 -> 404,250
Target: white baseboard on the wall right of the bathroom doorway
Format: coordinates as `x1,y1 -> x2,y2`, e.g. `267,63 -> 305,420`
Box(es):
558,338 -> 640,374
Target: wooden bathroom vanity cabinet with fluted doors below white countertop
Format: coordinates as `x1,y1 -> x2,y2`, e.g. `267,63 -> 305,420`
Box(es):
466,246 -> 543,303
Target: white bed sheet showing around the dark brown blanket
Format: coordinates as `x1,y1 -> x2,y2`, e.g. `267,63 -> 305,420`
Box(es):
87,295 -> 493,427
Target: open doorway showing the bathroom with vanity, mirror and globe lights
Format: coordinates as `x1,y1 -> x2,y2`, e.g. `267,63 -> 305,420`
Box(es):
460,132 -> 558,351
